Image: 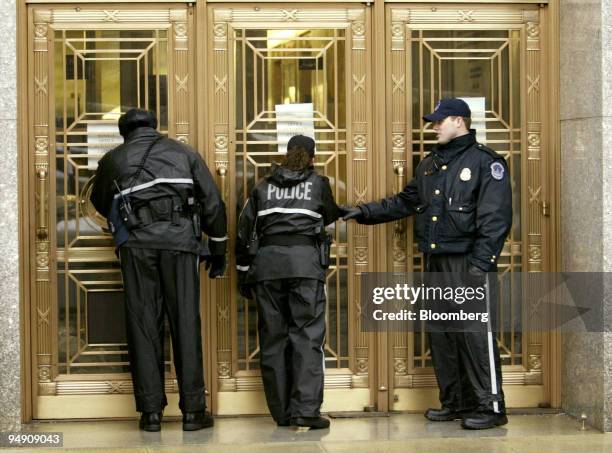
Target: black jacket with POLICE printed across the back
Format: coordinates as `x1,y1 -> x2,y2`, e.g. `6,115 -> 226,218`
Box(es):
236,165 -> 339,282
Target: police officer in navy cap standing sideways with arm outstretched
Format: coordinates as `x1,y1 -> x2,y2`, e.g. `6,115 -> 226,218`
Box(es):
342,99 -> 512,429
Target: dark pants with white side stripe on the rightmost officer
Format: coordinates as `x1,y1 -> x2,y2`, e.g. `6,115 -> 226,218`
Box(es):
427,254 -> 505,413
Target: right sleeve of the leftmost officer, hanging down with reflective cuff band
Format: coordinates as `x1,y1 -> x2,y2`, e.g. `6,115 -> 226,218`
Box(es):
191,153 -> 227,255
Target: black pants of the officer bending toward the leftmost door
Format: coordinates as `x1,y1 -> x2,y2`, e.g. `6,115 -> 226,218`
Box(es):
121,247 -> 206,412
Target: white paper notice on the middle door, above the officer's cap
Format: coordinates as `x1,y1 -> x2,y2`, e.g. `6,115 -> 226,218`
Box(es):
275,104 -> 315,154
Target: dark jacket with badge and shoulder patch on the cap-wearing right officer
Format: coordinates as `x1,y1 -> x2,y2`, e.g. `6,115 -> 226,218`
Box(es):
357,130 -> 512,272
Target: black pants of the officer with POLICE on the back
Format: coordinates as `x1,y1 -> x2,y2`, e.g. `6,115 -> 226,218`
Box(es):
255,278 -> 325,422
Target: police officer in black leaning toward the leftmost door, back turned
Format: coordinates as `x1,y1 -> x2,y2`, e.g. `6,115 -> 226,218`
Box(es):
91,109 -> 227,431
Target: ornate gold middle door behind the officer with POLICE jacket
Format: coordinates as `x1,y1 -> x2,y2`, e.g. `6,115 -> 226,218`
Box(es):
208,4 -> 373,414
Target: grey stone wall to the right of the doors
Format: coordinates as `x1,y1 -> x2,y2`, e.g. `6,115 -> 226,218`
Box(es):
560,0 -> 612,431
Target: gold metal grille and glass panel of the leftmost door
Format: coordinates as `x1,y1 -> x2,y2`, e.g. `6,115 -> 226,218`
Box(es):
54,30 -> 171,374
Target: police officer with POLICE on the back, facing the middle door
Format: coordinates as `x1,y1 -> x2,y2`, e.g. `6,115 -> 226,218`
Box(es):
236,135 -> 339,429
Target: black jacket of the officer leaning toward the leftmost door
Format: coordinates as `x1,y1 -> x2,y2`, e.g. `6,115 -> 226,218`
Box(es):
90,127 -> 227,255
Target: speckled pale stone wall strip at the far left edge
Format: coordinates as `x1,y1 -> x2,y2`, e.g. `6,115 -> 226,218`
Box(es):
0,0 -> 21,431
